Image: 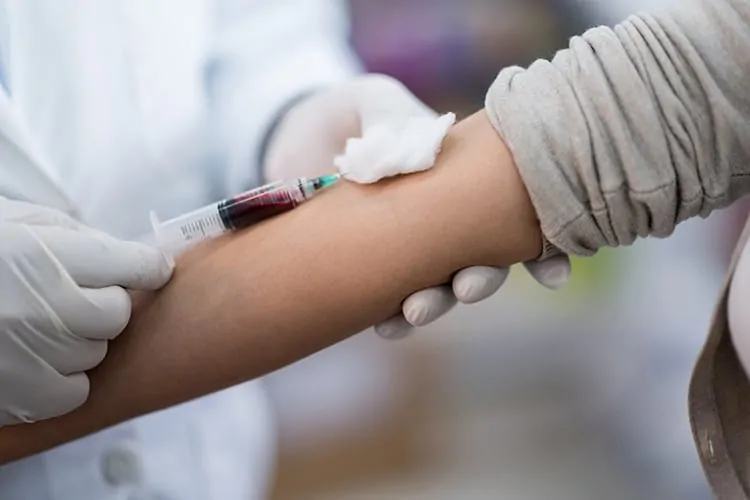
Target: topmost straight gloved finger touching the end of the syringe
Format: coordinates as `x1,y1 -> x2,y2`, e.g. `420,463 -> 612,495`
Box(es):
29,226 -> 174,290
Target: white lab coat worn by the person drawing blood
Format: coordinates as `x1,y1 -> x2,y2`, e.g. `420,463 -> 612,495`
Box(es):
0,0 -> 356,500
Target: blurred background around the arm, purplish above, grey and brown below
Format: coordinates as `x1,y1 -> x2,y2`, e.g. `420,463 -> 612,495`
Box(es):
267,0 -> 747,500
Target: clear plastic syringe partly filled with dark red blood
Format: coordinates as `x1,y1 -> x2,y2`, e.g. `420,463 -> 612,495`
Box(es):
151,173 -> 341,253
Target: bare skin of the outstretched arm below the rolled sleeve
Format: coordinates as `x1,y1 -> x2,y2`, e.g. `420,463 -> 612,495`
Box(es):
0,114 -> 541,463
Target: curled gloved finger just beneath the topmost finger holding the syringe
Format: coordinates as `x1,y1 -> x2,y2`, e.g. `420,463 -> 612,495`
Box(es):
55,286 -> 131,340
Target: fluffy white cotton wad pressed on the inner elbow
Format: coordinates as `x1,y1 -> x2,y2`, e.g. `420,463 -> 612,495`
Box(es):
333,113 -> 456,184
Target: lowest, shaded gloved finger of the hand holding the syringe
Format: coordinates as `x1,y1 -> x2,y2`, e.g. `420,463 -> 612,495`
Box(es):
0,369 -> 90,426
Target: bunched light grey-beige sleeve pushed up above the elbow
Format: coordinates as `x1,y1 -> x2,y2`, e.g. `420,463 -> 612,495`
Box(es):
486,0 -> 750,255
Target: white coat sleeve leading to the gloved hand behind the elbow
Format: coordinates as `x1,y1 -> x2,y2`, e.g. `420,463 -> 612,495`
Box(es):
206,0 -> 359,195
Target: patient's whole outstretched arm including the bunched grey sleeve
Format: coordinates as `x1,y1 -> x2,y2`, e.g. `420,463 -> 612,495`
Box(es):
10,0 -> 750,463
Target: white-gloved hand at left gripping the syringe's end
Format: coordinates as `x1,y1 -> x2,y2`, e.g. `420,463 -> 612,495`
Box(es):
0,198 -> 173,426
